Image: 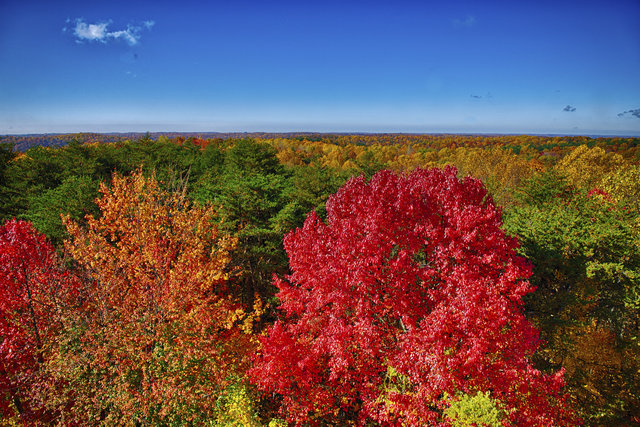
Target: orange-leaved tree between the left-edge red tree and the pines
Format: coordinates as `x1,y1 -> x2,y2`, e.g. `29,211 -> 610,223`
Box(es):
49,171 -> 253,425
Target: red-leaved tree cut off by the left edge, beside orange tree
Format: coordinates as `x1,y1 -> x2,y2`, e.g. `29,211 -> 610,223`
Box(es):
0,219 -> 74,421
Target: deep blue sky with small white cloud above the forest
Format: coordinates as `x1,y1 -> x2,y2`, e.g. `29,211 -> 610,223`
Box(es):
0,0 -> 640,135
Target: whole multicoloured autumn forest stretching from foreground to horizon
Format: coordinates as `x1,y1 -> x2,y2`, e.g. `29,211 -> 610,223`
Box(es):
0,133 -> 640,426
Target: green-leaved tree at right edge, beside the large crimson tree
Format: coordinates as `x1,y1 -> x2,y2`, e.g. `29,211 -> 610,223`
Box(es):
505,179 -> 640,331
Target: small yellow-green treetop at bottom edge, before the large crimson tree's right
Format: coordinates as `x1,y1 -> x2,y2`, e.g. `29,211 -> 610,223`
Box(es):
444,391 -> 505,427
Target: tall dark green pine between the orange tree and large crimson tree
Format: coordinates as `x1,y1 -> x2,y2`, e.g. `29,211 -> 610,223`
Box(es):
191,140 -> 295,307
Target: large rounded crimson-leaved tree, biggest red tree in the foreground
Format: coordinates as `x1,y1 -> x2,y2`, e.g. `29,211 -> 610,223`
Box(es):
252,168 -> 571,425
